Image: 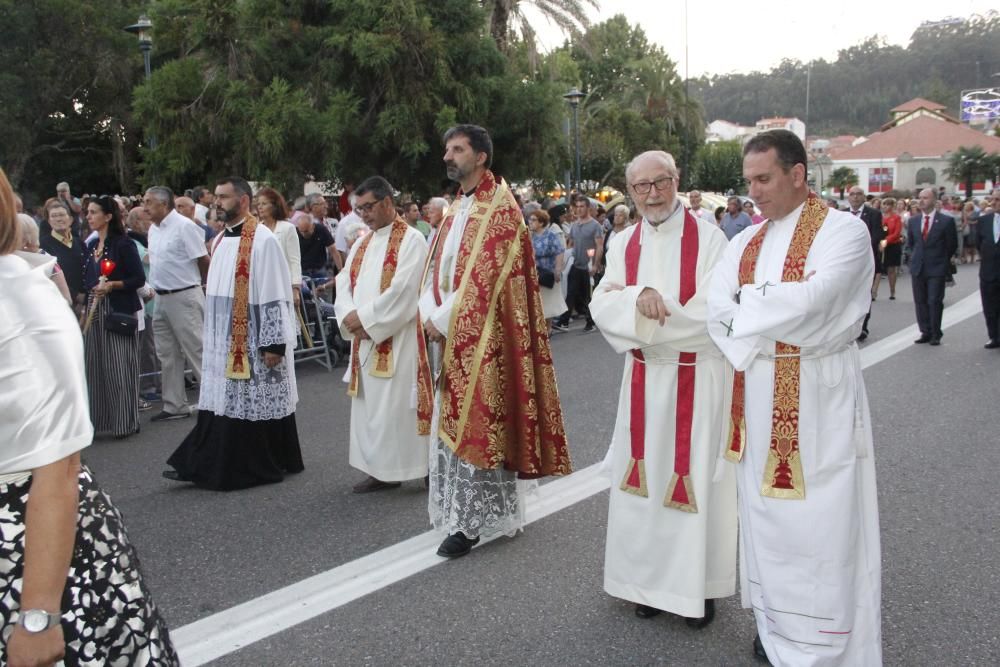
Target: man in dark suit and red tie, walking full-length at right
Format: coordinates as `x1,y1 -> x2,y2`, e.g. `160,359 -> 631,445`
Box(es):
906,188 -> 958,345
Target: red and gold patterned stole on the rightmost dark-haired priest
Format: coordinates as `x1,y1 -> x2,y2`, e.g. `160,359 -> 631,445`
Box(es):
726,193 -> 828,499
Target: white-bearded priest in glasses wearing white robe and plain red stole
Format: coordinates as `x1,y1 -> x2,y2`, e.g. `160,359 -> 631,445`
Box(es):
590,151 -> 736,628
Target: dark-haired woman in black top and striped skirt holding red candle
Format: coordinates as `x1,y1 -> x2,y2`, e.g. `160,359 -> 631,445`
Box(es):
83,195 -> 146,438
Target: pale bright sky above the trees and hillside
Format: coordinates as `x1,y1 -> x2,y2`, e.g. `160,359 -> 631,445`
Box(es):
525,0 -> 997,78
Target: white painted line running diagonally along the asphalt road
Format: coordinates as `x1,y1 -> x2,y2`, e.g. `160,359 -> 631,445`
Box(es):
170,292 -> 982,667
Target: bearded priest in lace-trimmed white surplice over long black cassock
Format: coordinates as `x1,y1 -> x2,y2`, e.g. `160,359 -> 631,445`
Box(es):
163,176 -> 303,491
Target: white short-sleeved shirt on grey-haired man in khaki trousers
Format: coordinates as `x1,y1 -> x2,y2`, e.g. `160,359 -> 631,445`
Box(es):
149,211 -> 208,290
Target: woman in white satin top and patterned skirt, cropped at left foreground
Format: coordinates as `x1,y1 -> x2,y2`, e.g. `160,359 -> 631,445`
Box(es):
0,170 -> 178,666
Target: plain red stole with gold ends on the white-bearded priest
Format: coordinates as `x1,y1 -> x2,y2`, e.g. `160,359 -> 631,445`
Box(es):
620,210 -> 698,513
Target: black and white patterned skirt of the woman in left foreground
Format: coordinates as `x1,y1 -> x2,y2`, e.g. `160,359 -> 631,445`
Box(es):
0,466 -> 180,667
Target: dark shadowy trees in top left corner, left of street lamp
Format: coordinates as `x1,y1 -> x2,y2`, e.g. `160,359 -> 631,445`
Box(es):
0,0 -> 142,203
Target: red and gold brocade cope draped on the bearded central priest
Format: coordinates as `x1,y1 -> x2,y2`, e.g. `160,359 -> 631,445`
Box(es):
418,171 -> 572,478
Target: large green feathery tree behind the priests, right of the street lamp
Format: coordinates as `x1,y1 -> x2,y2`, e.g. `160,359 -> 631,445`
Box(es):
135,0 -> 561,195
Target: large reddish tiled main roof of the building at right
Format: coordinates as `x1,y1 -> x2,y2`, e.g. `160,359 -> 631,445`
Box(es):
833,116 -> 1000,161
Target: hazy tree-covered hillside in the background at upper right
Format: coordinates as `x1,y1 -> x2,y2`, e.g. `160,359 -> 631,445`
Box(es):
690,12 -> 1000,134
